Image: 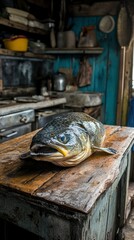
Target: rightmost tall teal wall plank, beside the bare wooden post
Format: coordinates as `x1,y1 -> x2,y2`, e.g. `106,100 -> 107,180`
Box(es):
104,19 -> 120,125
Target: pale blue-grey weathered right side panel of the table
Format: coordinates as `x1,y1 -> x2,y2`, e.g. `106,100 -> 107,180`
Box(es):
83,180 -> 120,240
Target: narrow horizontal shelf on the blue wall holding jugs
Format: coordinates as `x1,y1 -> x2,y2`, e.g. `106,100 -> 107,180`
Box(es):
44,47 -> 103,54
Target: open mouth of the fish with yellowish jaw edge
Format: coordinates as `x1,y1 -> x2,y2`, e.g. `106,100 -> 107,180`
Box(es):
31,144 -> 68,157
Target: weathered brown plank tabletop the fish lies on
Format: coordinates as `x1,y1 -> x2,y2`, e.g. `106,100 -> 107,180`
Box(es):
0,126 -> 134,239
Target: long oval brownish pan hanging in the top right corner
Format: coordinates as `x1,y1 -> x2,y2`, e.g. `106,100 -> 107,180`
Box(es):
117,0 -> 132,47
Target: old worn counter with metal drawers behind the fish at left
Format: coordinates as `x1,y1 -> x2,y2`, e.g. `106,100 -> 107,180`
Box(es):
0,96 -> 66,143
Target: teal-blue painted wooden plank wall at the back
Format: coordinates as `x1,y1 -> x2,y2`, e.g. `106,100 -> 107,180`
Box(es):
54,16 -> 120,125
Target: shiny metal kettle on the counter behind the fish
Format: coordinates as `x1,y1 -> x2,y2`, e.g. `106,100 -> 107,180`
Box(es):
53,72 -> 67,92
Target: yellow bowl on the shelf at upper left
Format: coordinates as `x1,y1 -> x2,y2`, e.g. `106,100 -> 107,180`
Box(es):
3,37 -> 28,52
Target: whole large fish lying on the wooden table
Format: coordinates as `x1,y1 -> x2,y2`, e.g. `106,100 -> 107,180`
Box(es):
20,112 -> 116,167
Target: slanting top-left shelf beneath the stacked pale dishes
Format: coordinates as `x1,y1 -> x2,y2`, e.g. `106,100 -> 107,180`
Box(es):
0,17 -> 47,35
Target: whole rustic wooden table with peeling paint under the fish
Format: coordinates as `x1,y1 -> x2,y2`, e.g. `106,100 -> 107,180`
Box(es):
0,126 -> 134,240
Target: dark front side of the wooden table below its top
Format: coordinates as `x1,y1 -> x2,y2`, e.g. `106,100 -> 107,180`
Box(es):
0,189 -> 82,240
